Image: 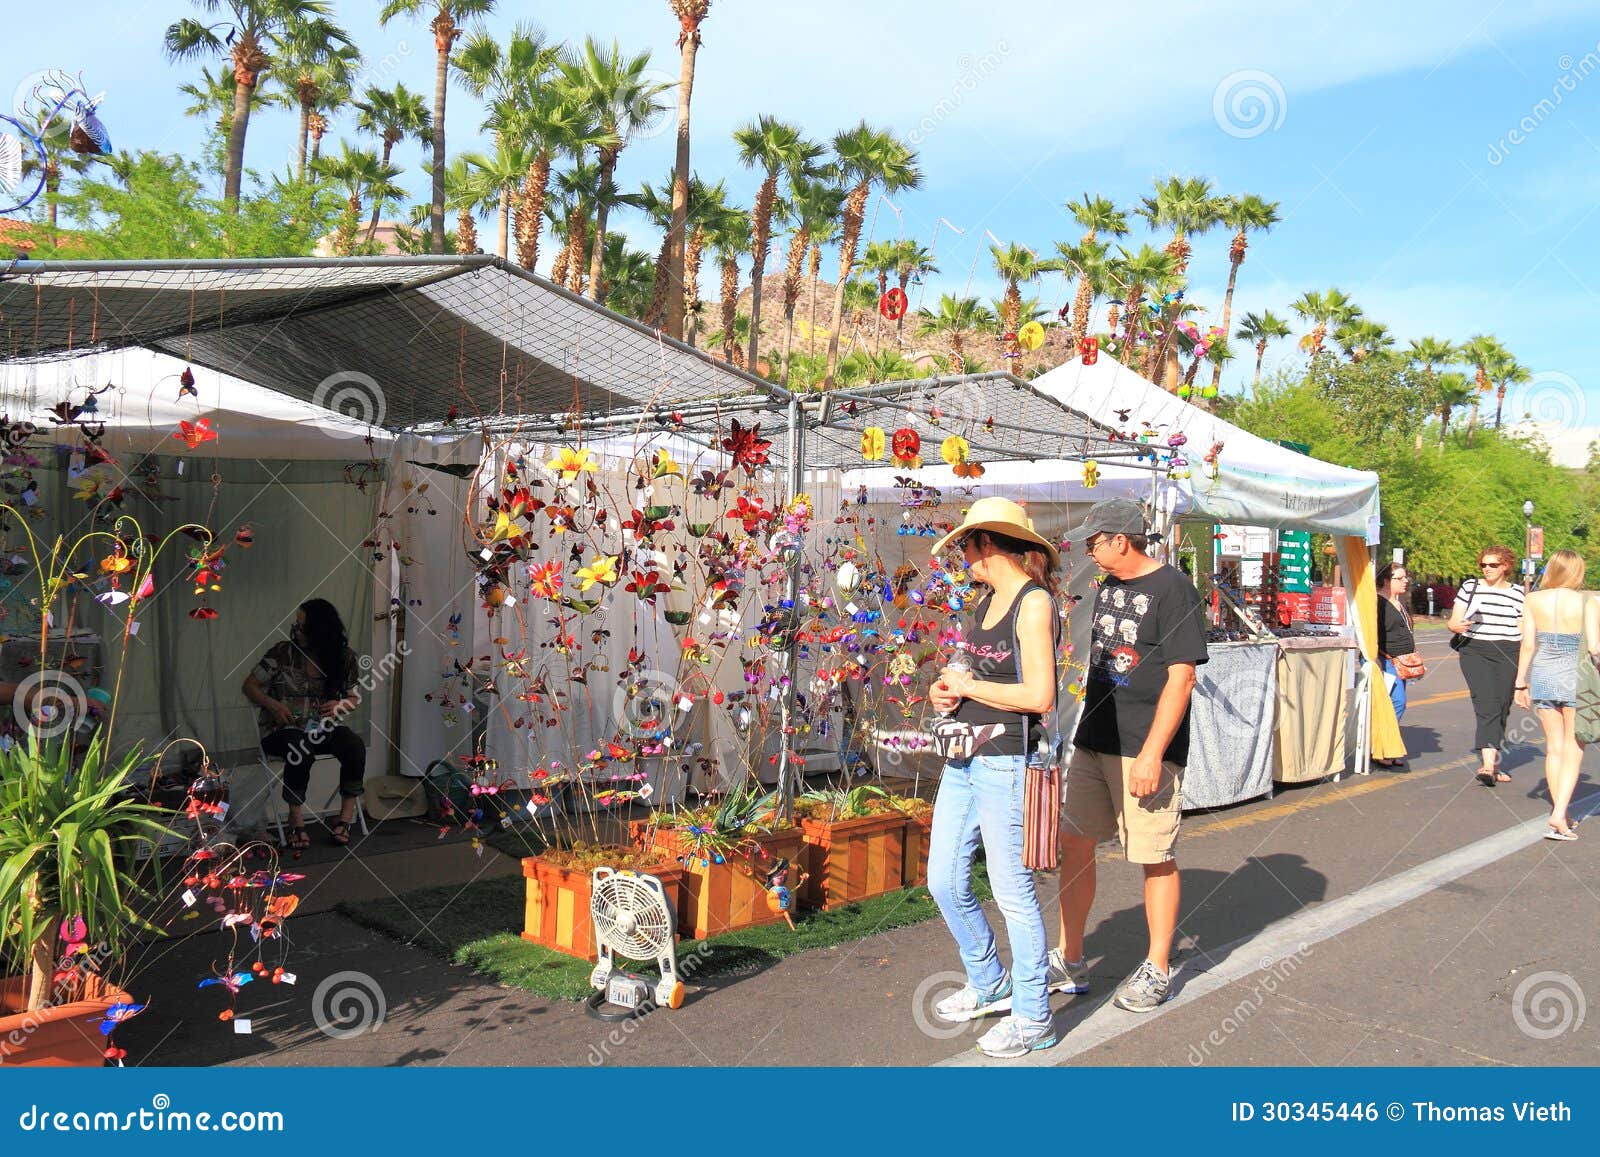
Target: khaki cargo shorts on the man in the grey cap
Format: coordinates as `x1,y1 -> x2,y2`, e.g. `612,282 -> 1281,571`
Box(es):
1061,747 -> 1184,864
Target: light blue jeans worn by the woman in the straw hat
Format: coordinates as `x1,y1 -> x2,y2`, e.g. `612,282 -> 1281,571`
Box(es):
928,755 -> 1050,1024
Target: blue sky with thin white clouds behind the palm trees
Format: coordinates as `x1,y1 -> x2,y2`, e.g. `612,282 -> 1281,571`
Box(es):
0,0 -> 1600,443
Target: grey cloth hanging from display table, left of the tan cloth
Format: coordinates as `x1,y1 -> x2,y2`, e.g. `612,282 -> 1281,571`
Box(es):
1184,642 -> 1278,811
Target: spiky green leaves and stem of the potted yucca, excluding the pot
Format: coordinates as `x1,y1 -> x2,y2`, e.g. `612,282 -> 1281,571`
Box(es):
0,731 -> 165,1010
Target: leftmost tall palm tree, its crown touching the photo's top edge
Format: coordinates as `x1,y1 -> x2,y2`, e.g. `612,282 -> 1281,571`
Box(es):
165,0 -> 350,213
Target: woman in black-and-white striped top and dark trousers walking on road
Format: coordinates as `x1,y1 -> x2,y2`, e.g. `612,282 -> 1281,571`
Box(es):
1448,546 -> 1523,787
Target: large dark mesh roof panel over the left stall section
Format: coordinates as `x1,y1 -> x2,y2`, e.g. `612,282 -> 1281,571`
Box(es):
0,256 -> 782,427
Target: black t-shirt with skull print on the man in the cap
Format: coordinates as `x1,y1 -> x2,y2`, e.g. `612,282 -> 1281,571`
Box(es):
1075,566 -> 1206,765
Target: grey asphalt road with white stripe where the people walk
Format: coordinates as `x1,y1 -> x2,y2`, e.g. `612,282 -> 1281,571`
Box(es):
123,631 -> 1600,1066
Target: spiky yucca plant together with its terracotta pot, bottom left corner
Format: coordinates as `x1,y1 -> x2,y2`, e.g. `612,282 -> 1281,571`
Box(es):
0,733 -> 165,1064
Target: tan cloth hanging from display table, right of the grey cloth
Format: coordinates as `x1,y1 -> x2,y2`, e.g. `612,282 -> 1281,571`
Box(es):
1272,639 -> 1354,784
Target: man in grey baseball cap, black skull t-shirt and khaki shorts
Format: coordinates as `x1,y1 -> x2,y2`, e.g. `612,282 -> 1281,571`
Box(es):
1050,498 -> 1206,1013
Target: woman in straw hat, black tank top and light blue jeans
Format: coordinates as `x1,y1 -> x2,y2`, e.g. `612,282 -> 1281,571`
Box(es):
928,498 -> 1061,1058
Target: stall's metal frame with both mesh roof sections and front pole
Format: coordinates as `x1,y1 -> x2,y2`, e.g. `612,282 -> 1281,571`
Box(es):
0,254 -> 1150,813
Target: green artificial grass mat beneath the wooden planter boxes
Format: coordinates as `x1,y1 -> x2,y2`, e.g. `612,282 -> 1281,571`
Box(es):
338,861 -> 992,1000
